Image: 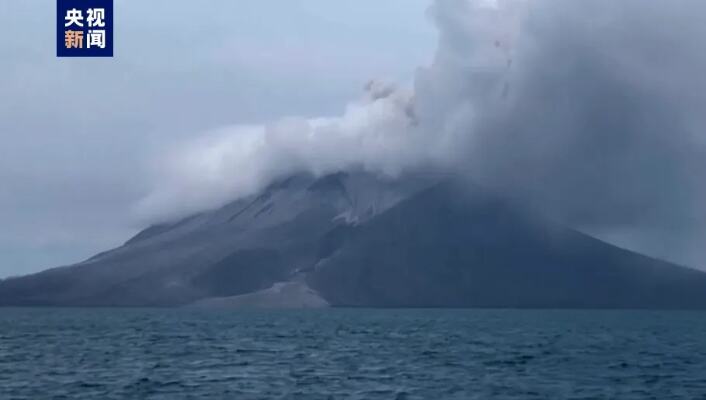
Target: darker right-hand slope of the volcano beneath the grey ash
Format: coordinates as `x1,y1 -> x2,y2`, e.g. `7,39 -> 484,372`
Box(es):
310,183 -> 706,308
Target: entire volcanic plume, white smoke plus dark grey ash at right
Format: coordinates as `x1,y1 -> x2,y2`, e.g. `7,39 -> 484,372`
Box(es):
137,0 -> 706,264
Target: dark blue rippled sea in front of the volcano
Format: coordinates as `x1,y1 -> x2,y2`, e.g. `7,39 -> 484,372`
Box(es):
0,309 -> 706,400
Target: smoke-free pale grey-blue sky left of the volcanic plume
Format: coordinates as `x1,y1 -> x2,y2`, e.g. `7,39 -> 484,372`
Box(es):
0,0 -> 436,278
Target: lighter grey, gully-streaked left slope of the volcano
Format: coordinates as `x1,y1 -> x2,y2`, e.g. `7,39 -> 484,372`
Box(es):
0,173 -> 433,306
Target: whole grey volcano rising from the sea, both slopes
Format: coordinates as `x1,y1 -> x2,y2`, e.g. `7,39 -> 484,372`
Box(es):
0,173 -> 706,308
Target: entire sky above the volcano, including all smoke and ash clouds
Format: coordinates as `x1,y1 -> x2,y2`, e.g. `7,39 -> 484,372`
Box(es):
0,0 -> 706,277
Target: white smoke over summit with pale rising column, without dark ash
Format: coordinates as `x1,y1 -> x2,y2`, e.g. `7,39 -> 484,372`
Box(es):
136,0 -> 517,221
